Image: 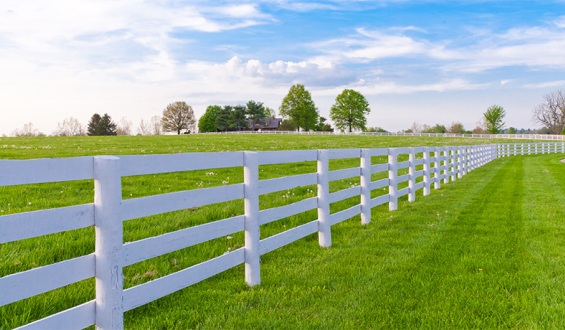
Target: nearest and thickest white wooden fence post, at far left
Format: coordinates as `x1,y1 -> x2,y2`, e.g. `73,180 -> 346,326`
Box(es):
93,156 -> 124,329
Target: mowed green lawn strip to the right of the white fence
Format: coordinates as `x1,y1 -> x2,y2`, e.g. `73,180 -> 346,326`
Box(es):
122,155 -> 565,329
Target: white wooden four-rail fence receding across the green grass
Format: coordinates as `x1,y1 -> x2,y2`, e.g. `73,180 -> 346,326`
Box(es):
0,143 -> 565,329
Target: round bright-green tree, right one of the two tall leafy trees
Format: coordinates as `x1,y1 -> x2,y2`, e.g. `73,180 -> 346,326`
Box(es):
330,89 -> 371,133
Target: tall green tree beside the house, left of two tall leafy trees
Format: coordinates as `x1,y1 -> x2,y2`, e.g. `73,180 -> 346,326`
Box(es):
279,84 -> 318,131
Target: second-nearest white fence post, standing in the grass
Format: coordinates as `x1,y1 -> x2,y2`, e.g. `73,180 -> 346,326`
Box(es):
243,151 -> 261,286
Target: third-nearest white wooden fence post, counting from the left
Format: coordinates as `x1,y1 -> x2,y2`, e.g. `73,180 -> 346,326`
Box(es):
317,150 -> 332,247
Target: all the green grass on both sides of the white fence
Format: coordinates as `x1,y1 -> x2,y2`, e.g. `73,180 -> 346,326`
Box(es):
0,135 -> 565,329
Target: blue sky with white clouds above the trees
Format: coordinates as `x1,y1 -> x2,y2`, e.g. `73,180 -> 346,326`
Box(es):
0,0 -> 565,135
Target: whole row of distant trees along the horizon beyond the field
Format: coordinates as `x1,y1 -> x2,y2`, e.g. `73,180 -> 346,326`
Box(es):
7,84 -> 565,136
